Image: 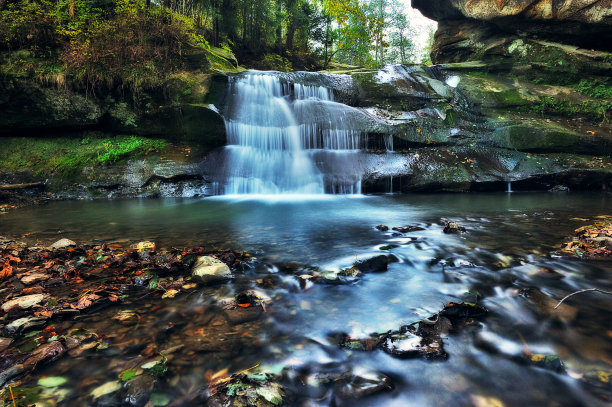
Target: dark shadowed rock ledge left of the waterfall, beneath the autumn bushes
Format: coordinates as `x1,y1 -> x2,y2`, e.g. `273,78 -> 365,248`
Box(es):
0,72 -> 225,149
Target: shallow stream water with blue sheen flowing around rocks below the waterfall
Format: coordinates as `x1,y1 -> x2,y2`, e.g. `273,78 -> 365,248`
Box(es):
0,193 -> 612,406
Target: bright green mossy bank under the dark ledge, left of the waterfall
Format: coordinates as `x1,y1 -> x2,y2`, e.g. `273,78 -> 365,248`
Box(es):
0,136 -> 167,177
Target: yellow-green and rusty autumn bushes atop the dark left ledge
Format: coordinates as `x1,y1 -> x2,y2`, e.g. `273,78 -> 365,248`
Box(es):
0,0 -> 209,90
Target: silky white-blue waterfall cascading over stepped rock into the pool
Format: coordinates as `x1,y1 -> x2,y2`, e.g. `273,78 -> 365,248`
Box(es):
217,71 -> 367,195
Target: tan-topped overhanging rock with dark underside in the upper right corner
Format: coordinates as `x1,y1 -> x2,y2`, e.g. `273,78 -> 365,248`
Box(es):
412,0 -> 612,56
